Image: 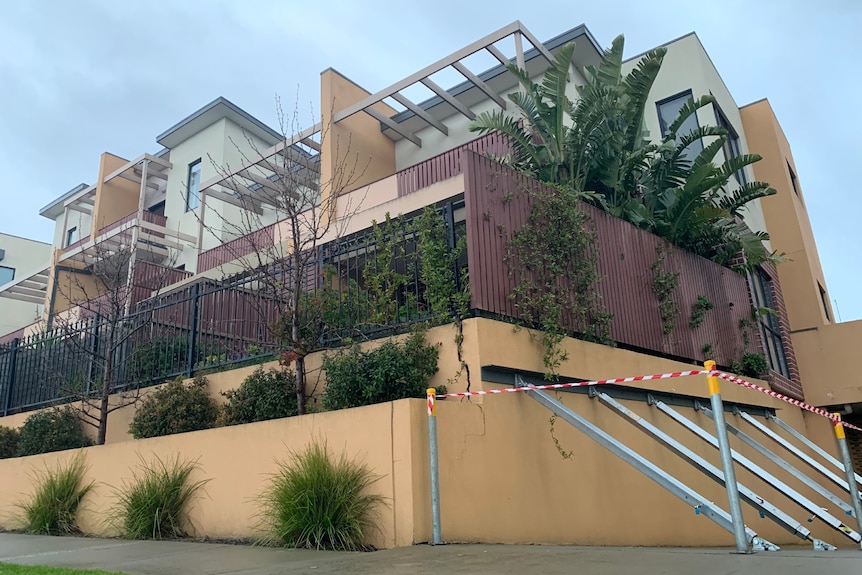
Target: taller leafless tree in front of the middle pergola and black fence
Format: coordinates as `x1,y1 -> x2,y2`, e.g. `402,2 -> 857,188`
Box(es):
194,99 -> 368,415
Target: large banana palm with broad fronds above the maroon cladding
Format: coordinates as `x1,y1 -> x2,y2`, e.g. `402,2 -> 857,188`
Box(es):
470,32 -> 780,268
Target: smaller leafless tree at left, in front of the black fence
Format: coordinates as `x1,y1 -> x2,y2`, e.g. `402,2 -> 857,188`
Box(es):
47,238 -> 181,445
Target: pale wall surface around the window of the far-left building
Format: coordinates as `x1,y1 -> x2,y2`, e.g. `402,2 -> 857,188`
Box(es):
0,234 -> 51,335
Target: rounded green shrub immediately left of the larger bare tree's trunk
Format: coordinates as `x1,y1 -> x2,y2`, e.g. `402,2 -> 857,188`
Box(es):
222,367 -> 297,425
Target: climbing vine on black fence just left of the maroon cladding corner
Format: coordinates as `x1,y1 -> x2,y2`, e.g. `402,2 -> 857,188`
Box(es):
413,207 -> 471,391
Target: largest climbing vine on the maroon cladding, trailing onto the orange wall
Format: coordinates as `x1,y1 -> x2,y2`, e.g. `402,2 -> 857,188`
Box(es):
505,186 -> 613,379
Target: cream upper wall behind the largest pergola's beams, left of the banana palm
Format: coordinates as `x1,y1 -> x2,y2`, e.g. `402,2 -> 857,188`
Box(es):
395,66 -> 586,171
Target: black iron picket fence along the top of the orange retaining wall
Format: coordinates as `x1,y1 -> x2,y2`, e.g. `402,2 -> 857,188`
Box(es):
0,201 -> 466,416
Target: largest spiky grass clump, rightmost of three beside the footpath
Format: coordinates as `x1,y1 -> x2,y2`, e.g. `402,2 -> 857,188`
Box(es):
261,442 -> 383,551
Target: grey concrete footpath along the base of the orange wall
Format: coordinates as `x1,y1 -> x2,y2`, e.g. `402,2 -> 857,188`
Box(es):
0,533 -> 862,575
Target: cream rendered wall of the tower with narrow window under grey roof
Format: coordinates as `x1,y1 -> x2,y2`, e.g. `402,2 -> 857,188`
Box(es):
165,118 -> 276,271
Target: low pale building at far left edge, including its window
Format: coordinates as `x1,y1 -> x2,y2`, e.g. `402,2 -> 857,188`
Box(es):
0,233 -> 51,341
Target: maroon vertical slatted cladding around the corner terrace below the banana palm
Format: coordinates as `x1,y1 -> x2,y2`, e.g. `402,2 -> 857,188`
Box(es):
461,150 -> 751,366
